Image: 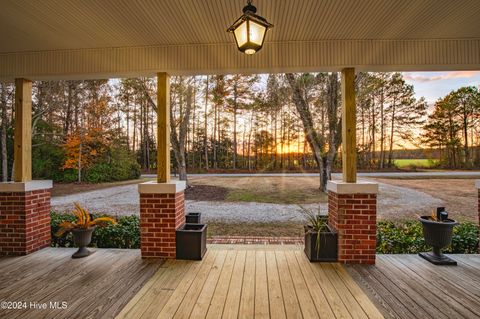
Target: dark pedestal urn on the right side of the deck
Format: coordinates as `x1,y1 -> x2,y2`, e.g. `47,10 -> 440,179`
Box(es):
419,207 -> 458,265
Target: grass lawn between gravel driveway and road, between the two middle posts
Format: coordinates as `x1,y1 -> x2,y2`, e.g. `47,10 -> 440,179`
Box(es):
190,176 -> 327,204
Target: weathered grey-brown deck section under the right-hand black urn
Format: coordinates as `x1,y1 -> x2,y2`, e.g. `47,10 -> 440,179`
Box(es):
346,255 -> 480,319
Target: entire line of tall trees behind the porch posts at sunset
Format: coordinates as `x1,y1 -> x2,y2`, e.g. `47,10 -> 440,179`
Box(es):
0,73 -> 479,185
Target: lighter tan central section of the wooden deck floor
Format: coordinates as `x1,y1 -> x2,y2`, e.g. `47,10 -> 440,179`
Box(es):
117,245 -> 382,319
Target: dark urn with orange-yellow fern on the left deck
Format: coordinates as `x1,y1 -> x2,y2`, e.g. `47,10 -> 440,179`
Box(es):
55,203 -> 116,258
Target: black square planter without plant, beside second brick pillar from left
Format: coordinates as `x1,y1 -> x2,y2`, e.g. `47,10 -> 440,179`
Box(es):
175,224 -> 207,260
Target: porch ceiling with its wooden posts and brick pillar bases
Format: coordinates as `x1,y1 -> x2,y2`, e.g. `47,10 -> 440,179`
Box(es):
0,0 -> 480,264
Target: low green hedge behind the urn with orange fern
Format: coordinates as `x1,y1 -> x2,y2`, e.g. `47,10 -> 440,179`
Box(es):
50,212 -> 140,249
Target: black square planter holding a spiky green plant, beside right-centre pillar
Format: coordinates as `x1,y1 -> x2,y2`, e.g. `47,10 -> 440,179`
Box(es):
301,207 -> 338,262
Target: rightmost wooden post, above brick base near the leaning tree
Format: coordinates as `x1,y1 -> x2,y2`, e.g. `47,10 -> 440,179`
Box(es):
342,68 -> 357,183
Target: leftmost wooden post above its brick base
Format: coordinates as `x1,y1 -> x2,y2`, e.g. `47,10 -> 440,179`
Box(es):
13,79 -> 32,182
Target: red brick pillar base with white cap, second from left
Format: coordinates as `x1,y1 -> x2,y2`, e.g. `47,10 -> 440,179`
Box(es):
138,181 -> 185,258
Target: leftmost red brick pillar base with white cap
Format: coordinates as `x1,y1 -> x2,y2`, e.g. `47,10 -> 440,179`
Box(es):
0,181 -> 52,256
